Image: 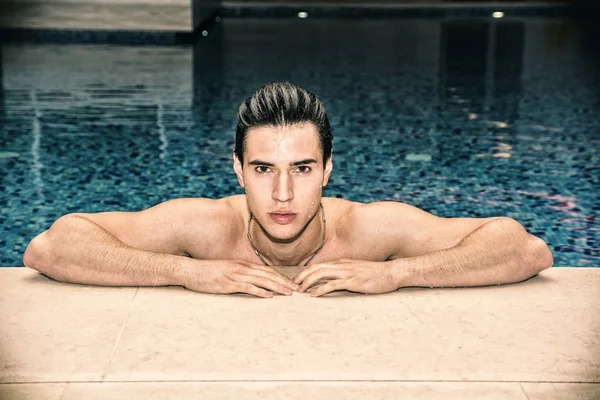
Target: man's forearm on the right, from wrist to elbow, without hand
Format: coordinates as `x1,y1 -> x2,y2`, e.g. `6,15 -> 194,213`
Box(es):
389,218 -> 553,288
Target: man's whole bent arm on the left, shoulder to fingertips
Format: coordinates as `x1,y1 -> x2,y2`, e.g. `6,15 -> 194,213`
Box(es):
23,199 -> 296,297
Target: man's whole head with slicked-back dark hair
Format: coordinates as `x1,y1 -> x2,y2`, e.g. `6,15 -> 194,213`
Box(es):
233,82 -> 332,242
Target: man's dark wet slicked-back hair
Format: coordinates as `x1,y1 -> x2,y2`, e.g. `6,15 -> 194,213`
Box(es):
234,82 -> 333,165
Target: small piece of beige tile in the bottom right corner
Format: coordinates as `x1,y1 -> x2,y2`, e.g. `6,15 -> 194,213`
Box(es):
521,383 -> 600,400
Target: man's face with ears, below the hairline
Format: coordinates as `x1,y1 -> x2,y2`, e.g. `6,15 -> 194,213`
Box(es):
234,123 -> 332,241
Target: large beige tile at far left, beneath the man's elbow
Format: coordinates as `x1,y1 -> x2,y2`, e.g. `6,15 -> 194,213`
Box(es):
0,268 -> 137,382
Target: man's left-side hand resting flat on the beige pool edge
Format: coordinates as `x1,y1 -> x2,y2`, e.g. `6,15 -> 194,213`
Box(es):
182,260 -> 298,297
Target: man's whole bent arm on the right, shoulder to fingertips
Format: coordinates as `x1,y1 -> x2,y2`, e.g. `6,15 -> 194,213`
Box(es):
294,202 -> 553,296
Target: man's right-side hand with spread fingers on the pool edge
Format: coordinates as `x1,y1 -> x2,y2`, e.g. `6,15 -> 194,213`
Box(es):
293,259 -> 399,297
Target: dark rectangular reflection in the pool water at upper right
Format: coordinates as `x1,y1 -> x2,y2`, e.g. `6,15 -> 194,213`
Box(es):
440,19 -> 525,160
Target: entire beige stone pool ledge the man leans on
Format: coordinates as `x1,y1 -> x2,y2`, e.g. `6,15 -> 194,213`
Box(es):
0,267 -> 600,400
